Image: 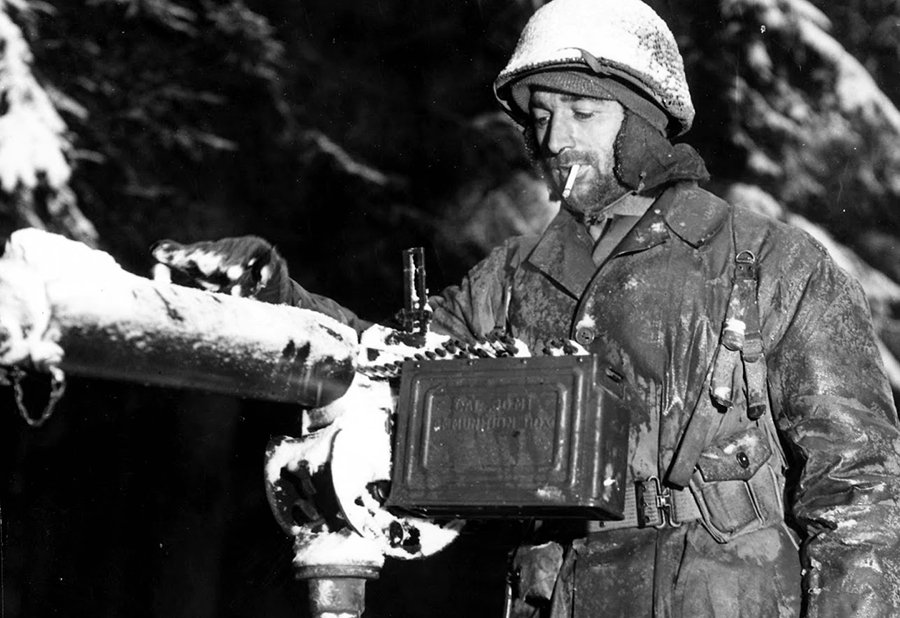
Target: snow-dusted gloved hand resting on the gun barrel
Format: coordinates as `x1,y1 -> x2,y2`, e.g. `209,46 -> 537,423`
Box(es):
150,236 -> 290,303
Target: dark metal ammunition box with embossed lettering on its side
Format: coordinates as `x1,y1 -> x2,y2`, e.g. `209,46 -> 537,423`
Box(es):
387,356 -> 629,519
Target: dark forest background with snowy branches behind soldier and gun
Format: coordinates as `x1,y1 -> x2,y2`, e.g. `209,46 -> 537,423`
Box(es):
0,0 -> 900,618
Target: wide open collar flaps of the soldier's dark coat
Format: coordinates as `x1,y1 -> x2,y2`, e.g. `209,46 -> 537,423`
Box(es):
528,182 -> 728,298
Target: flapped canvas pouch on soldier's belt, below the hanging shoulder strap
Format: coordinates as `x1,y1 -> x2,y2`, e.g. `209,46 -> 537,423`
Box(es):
690,425 -> 784,543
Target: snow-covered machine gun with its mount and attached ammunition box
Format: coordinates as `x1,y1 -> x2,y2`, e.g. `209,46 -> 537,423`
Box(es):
0,230 -> 628,616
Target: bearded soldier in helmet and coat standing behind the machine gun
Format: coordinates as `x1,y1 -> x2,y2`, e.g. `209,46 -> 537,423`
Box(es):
157,0 -> 900,618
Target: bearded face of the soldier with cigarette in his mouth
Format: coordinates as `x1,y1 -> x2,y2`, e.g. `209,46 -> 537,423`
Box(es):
529,90 -> 627,212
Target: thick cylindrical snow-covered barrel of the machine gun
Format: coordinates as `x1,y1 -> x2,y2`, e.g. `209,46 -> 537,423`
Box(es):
0,228 -> 358,407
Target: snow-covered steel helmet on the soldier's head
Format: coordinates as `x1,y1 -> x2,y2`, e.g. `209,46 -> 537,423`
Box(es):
494,0 -> 694,135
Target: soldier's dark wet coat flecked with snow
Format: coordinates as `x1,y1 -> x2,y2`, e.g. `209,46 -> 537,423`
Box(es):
286,183 -> 900,618
